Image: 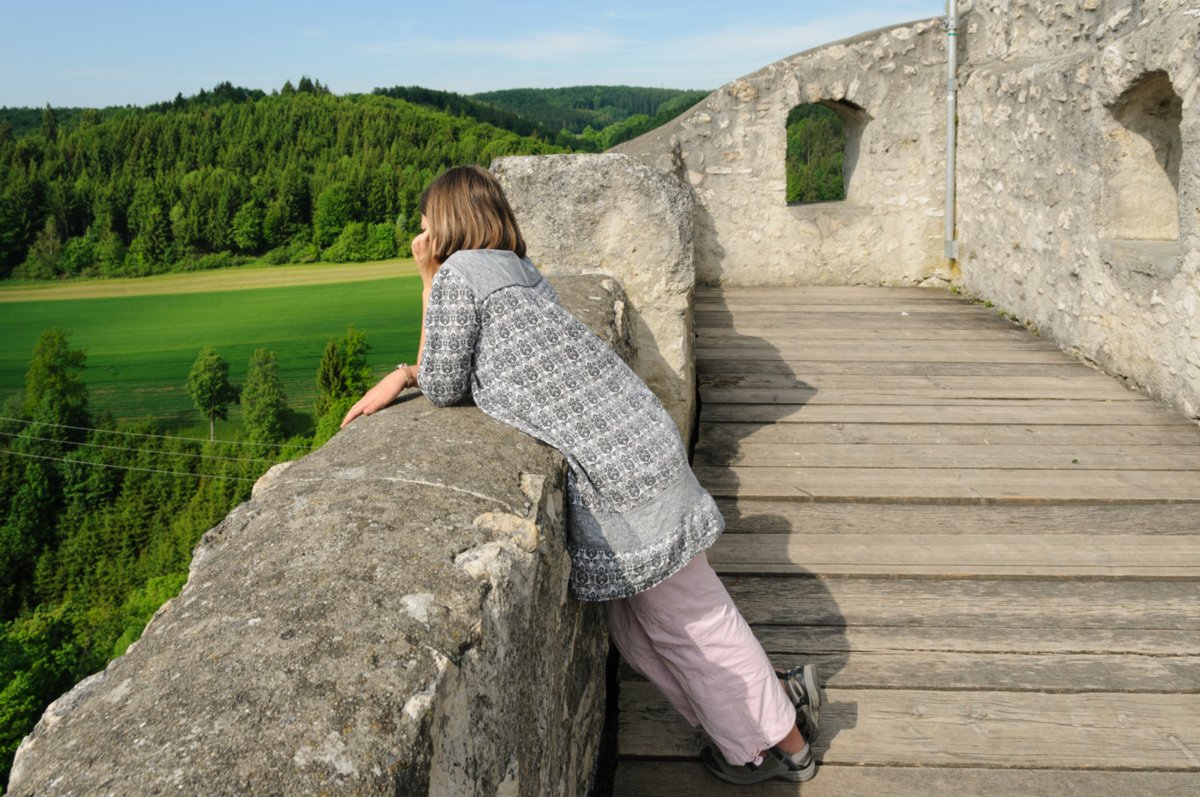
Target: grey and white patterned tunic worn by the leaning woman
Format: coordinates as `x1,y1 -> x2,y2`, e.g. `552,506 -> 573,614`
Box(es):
419,250 -> 725,600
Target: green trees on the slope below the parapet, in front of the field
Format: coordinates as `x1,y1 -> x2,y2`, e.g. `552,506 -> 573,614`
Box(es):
0,326 -> 372,789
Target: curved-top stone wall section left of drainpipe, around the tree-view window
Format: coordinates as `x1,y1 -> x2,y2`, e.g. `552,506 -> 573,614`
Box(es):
614,19 -> 950,286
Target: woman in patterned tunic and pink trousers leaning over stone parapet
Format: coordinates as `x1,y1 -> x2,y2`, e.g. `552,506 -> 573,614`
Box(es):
342,167 -> 821,783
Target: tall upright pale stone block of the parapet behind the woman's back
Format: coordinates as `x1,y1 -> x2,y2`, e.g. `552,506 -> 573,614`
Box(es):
492,154 -> 696,442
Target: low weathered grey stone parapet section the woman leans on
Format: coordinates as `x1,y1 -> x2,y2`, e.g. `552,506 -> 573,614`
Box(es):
8,276 -> 629,797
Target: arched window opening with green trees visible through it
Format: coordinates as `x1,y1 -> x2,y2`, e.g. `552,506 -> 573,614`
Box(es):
787,101 -> 866,204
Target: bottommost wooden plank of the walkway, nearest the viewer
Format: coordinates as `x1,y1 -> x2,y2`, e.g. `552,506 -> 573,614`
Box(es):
613,759 -> 1200,797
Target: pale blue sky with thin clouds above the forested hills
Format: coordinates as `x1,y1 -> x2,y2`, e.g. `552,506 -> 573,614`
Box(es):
0,0 -> 946,107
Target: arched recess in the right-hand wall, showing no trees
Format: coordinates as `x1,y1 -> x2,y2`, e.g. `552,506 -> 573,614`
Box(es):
1100,72 -> 1183,241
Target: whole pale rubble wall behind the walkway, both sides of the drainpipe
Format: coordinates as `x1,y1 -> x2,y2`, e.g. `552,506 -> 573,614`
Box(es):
614,0 -> 1200,418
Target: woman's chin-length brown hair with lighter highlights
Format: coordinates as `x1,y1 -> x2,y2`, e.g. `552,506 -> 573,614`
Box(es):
420,166 -> 526,263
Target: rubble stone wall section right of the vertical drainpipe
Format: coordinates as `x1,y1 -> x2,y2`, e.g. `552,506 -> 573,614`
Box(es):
958,0 -> 1200,417
